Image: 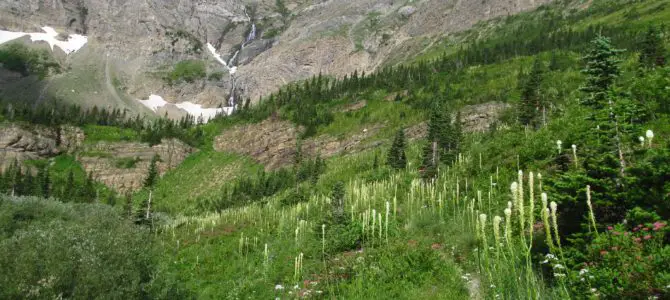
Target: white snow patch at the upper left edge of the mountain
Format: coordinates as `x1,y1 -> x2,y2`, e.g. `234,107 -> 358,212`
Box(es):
0,26 -> 88,55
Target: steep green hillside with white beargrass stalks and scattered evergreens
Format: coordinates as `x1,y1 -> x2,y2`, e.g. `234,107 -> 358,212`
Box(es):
0,0 -> 670,299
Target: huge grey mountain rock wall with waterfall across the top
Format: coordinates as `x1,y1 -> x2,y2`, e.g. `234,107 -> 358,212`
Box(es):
0,0 -> 551,111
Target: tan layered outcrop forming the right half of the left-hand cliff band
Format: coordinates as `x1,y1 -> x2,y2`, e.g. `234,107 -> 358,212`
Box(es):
77,139 -> 194,192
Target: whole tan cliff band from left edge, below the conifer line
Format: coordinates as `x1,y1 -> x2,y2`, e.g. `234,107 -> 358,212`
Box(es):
0,125 -> 195,192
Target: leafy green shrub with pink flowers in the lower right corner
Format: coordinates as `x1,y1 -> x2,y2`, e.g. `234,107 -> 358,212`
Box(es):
572,221 -> 670,299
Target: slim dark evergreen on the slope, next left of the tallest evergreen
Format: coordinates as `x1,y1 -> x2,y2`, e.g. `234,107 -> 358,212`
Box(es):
518,57 -> 545,125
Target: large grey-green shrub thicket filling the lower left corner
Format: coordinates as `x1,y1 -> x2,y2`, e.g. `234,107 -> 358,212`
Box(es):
0,196 -> 186,299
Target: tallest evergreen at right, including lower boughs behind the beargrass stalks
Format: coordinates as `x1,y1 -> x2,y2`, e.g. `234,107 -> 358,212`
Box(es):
548,37 -> 630,240
